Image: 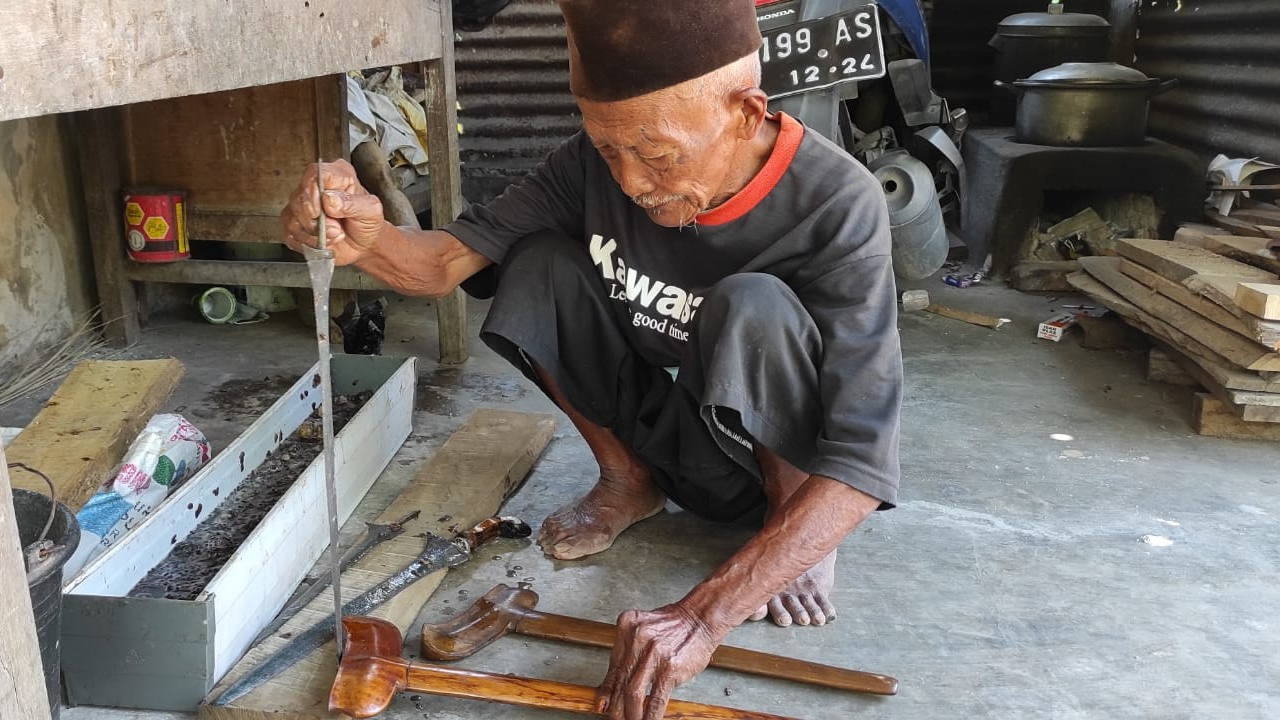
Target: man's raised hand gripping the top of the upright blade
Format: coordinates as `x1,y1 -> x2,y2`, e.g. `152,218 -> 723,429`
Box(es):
280,160 -> 390,265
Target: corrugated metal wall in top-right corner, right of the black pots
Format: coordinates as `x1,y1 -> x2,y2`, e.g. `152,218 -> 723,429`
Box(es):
1135,0 -> 1280,163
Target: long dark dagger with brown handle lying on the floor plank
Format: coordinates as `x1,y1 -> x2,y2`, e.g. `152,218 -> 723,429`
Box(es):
212,518 -> 530,706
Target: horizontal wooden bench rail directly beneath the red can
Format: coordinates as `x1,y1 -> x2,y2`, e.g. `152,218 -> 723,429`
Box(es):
125,260 -> 388,289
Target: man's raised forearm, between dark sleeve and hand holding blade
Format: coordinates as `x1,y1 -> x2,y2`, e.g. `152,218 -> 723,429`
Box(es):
356,223 -> 489,297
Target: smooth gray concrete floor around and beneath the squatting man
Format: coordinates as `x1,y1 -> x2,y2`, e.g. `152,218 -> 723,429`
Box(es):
15,283 -> 1280,720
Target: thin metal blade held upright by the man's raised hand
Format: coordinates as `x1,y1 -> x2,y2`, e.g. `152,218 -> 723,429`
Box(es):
302,161 -> 343,657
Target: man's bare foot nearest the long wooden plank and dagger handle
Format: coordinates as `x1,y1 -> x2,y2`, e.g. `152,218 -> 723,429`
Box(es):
538,475 -> 667,560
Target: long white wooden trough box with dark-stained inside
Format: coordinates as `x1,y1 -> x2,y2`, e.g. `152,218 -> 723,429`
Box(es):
61,355 -> 416,711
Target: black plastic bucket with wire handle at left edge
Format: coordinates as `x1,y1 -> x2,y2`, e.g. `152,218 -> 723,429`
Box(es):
13,488 -> 79,720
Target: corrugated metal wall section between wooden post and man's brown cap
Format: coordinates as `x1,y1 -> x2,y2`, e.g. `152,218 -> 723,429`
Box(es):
456,0 -> 580,202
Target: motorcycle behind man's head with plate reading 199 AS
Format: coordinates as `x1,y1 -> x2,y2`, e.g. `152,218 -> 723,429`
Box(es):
755,0 -> 968,279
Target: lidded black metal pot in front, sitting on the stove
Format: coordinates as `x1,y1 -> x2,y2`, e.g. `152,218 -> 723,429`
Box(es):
996,63 -> 1178,146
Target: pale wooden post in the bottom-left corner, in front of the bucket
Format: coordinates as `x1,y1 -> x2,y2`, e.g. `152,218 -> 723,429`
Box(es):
0,447 -> 49,720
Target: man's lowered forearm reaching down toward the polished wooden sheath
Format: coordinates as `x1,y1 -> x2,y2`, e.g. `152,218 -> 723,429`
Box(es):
681,475 -> 881,639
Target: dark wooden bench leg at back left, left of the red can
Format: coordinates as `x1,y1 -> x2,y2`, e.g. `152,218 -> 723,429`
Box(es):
76,108 -> 141,347
